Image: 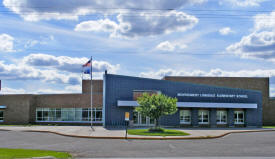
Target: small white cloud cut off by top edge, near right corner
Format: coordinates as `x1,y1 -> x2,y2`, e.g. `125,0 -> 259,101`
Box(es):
223,0 -> 267,7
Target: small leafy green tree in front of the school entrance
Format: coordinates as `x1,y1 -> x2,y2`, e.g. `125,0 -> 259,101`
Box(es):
135,93 -> 178,129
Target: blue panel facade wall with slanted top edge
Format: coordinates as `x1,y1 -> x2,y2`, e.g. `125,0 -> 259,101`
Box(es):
104,74 -> 262,126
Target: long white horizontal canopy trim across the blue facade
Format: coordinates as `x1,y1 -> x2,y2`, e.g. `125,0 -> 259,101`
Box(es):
117,100 -> 258,109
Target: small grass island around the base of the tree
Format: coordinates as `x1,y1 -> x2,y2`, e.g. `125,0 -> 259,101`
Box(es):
128,129 -> 190,136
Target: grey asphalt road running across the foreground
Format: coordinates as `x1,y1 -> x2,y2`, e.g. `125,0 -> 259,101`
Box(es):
0,131 -> 275,157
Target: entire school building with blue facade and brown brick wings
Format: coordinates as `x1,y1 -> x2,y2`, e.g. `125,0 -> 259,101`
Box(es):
0,73 -> 275,127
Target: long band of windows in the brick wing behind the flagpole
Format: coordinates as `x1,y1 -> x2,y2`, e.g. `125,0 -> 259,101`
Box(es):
36,108 -> 102,123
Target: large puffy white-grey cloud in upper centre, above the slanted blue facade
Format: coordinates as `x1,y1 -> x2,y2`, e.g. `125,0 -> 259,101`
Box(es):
75,11 -> 198,38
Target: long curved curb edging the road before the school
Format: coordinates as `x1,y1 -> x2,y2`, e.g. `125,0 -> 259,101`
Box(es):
0,129 -> 275,140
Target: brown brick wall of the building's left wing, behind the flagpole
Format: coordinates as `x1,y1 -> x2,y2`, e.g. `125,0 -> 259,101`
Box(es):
0,80 -> 103,124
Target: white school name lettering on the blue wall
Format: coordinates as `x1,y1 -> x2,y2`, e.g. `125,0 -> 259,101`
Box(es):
177,93 -> 248,98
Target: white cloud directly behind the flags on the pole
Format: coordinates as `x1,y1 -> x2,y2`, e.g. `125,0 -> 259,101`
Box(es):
23,53 -> 120,73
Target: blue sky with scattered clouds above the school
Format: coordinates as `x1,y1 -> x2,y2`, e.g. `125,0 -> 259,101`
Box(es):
0,0 -> 275,96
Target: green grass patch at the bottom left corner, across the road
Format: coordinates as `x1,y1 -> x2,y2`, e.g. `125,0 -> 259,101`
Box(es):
0,148 -> 72,159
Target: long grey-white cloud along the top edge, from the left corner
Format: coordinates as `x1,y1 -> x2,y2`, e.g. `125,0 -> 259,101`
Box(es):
3,0 -> 206,21
